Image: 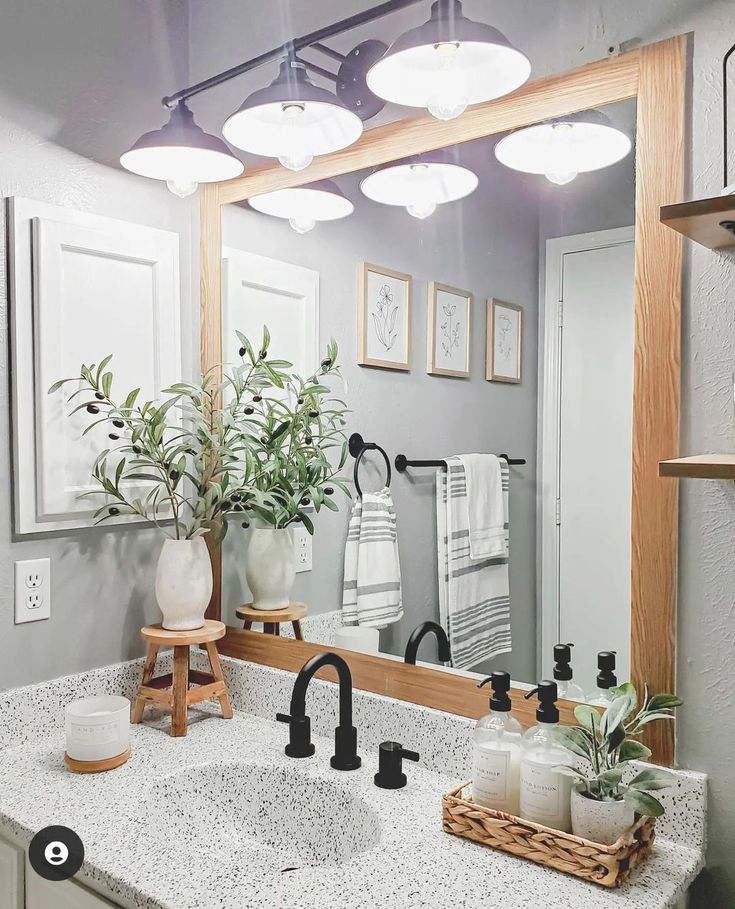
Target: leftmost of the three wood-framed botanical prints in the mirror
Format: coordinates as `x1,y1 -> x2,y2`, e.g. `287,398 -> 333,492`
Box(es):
357,262 -> 411,370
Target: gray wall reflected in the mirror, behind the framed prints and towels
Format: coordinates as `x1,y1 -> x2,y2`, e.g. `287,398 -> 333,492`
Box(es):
224,141 -> 538,681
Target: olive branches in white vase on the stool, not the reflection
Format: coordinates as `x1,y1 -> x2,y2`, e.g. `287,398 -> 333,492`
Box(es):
49,329 -> 290,631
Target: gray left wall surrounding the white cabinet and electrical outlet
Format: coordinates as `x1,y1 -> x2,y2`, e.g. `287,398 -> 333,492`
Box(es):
0,0 -> 197,687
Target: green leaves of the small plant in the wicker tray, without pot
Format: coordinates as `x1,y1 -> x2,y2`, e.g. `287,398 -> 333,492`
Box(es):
555,682 -> 683,817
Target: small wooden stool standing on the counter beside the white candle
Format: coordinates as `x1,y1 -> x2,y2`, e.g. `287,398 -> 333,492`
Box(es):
132,619 -> 232,735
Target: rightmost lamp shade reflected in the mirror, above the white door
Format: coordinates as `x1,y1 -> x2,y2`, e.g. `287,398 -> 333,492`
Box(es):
495,110 -> 633,186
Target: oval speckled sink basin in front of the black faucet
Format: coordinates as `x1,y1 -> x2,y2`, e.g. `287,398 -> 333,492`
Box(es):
146,764 -> 380,873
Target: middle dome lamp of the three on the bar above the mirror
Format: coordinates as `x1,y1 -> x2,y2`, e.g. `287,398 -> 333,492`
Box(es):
222,57 -> 363,171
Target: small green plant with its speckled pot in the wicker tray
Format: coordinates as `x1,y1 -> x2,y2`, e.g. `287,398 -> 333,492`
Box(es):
555,682 -> 682,845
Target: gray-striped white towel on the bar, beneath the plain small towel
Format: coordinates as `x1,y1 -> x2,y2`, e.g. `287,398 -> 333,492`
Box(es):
436,457 -> 511,669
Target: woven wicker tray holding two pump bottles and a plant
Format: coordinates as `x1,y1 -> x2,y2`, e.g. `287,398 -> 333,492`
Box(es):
442,782 -> 656,887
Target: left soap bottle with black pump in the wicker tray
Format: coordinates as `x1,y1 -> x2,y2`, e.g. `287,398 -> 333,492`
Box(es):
472,672 -> 523,815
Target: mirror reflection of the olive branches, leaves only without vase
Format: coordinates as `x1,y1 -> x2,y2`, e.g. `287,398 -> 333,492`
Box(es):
230,332 -> 350,533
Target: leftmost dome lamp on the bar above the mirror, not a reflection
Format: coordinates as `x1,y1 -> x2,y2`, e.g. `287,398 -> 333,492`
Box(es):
120,101 -> 245,198
